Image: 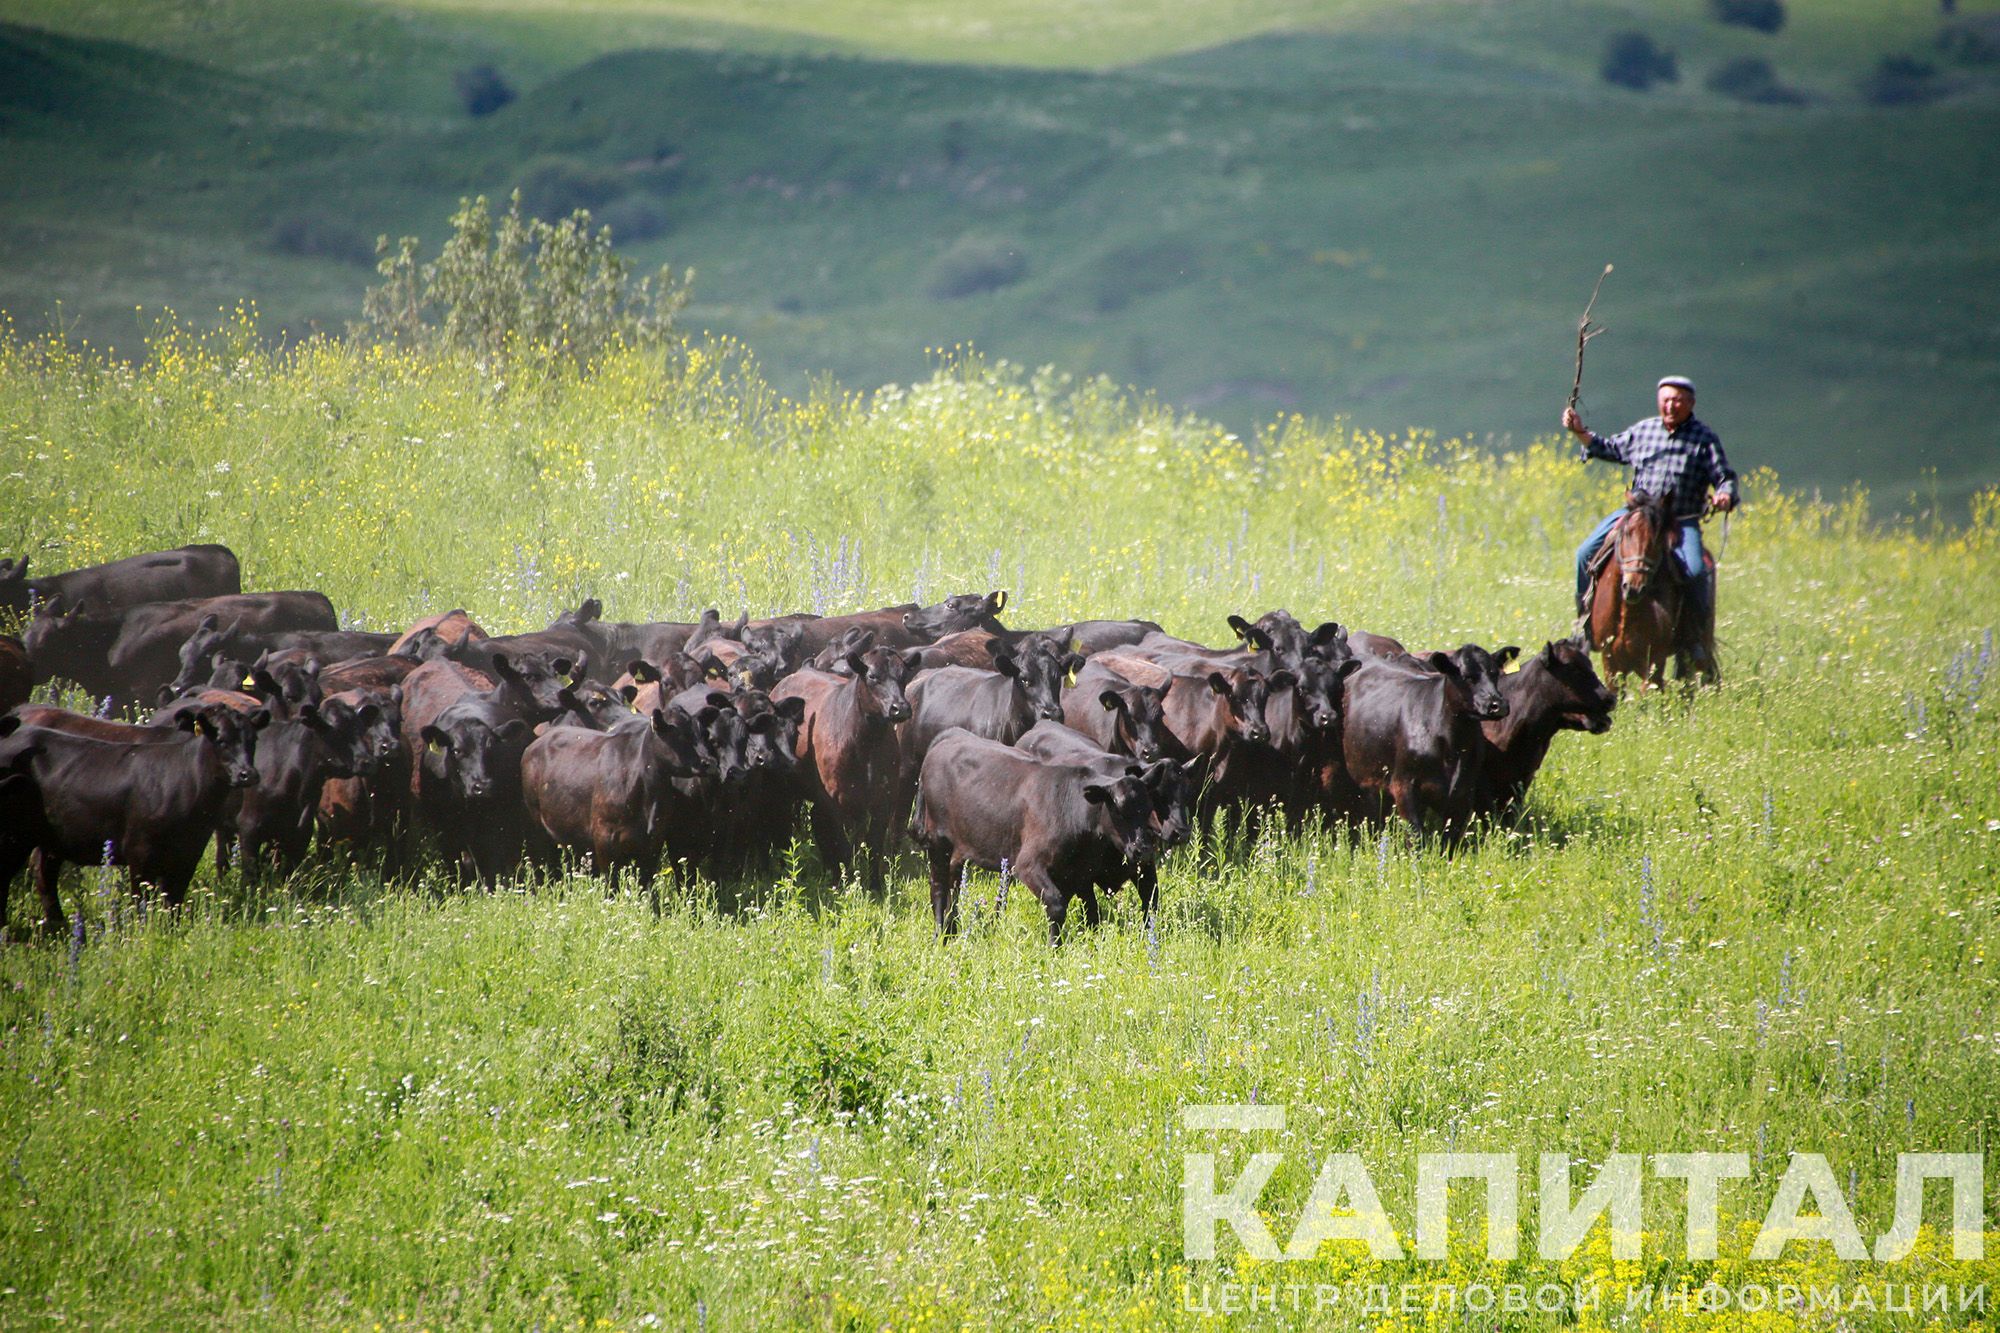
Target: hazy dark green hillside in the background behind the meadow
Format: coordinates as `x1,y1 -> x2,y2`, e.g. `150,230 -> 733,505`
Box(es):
0,0 -> 2000,506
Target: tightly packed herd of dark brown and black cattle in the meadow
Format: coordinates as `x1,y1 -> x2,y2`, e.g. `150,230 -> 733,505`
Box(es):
0,546 -> 1614,939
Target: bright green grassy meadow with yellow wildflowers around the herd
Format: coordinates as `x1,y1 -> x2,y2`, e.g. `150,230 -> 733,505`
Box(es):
0,320 -> 2000,1329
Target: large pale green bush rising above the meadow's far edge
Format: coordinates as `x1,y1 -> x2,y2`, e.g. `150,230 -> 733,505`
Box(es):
356,190 -> 694,362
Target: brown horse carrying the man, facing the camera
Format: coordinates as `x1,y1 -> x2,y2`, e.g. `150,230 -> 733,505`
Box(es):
1590,490 -> 1714,689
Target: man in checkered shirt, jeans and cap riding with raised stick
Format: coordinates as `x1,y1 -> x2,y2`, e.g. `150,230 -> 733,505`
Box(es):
1562,374 -> 1742,671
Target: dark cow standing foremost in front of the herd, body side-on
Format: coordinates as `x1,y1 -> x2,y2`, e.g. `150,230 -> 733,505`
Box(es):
910,731 -> 1160,945
